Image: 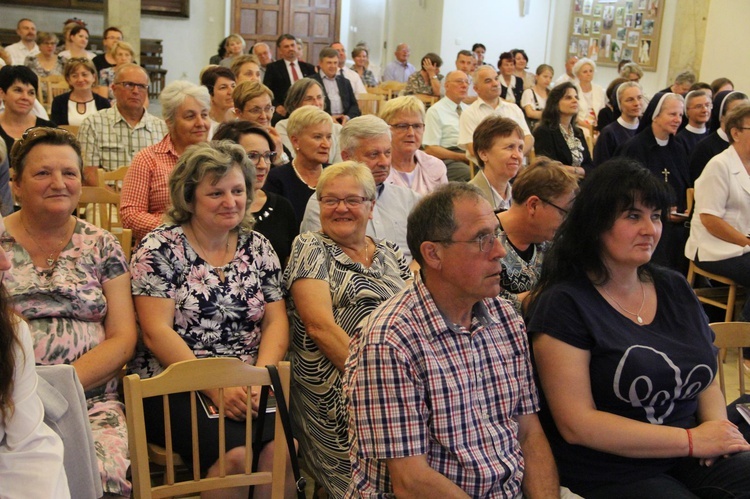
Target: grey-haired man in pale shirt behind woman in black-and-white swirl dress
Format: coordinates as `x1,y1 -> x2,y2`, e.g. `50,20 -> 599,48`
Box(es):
300,115 -> 419,262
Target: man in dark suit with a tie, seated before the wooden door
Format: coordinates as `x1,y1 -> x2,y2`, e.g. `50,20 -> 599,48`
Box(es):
263,33 -> 315,116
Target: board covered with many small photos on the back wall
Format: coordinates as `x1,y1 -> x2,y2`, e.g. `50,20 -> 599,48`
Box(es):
566,0 -> 663,71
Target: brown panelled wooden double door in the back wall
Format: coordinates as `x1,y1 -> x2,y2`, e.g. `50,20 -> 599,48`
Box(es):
232,0 -> 341,64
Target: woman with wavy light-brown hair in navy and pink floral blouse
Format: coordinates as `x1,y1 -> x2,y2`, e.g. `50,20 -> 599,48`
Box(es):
130,141 -> 293,497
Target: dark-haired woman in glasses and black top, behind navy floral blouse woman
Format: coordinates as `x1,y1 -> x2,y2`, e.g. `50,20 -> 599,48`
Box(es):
214,120 -> 299,268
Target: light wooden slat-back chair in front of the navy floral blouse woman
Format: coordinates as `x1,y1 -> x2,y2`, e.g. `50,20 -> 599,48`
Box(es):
124,357 -> 289,499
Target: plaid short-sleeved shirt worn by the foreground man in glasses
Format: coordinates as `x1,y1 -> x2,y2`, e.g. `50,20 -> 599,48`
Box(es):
345,277 -> 539,498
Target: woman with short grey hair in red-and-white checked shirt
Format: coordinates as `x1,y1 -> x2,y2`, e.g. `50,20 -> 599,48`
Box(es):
120,80 -> 211,241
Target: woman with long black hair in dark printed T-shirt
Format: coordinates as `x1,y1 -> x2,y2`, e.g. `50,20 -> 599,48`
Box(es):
529,159 -> 750,499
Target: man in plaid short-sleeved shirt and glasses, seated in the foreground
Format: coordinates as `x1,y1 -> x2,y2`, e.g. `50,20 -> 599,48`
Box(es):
345,183 -> 559,498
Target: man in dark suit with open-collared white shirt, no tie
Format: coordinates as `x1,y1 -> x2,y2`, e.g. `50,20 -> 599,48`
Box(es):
312,47 -> 362,125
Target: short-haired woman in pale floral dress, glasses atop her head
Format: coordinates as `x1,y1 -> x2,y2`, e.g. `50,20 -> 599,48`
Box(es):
0,128 -> 137,497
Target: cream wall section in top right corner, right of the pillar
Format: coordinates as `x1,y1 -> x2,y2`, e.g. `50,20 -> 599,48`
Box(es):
700,0 -> 750,92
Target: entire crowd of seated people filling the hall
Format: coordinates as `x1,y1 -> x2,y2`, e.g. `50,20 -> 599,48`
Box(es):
0,16 -> 750,498
